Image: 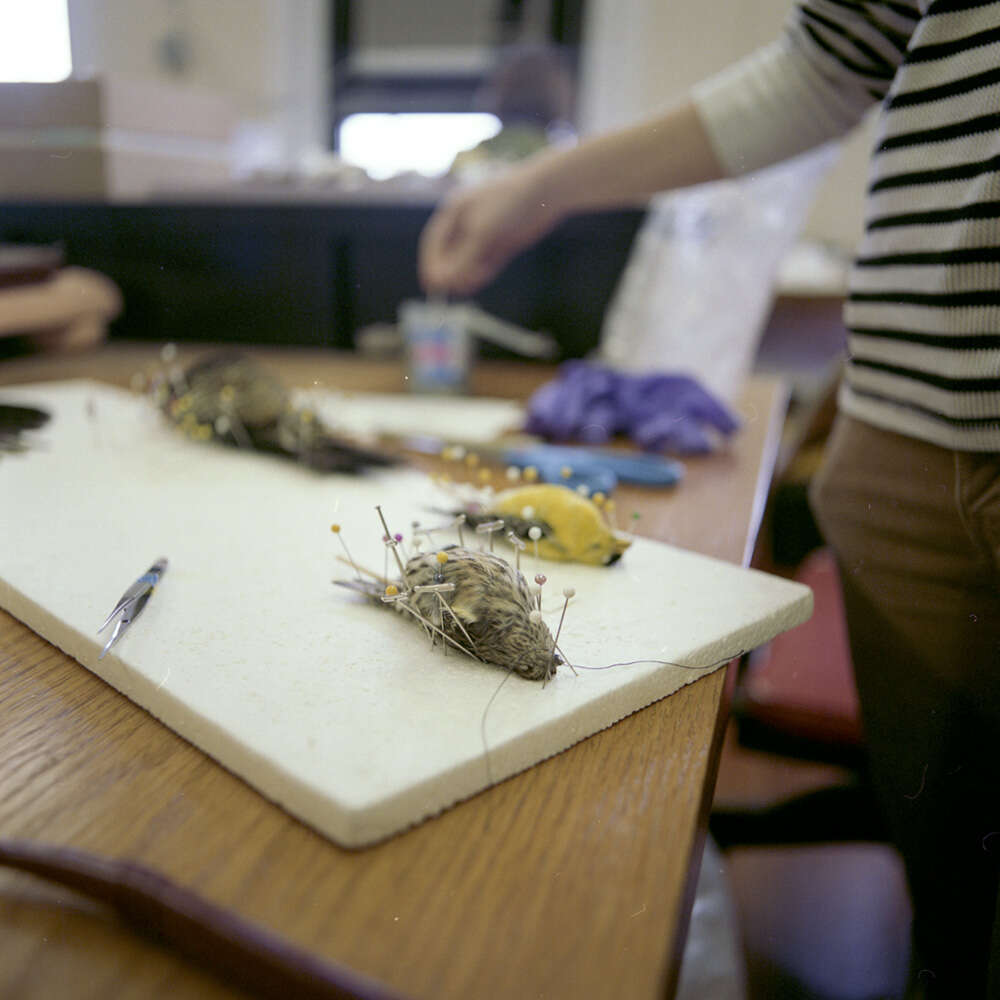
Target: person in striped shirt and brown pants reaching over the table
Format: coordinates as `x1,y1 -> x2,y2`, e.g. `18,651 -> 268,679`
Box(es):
419,0 -> 1000,998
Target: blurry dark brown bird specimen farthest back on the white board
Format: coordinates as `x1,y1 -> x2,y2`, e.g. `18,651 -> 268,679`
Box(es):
153,352 -> 396,472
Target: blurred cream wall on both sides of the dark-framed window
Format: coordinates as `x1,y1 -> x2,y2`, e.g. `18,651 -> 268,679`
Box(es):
52,0 -> 869,247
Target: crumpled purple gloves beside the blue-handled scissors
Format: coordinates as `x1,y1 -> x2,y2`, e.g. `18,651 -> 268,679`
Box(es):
525,361 -> 739,455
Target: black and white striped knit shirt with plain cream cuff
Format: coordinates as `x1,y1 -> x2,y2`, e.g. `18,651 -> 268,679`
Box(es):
695,0 -> 1000,451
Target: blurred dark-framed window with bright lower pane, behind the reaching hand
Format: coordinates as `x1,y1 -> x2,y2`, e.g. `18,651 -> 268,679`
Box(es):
330,0 -> 585,178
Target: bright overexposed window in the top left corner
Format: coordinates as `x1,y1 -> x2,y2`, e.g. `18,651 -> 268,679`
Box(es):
0,0 -> 73,83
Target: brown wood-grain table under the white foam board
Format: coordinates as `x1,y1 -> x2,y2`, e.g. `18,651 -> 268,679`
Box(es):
0,345 -> 785,1000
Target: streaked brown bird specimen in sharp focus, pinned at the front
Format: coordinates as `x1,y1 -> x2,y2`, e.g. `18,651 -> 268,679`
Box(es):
334,525 -> 563,681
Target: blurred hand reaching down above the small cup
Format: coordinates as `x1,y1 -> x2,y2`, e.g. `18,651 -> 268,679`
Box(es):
418,161 -> 562,295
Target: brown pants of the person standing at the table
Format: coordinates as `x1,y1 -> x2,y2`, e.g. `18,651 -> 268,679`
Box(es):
812,416 -> 1000,1000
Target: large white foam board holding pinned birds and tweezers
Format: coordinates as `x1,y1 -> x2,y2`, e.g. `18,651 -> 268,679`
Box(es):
0,381 -> 812,847
